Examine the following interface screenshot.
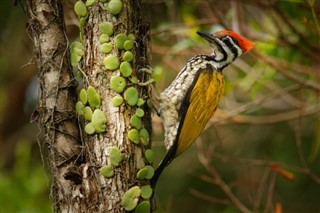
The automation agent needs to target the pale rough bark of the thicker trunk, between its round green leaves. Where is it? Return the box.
[82,0,151,212]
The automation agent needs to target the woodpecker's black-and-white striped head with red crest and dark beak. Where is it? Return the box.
[197,30,254,69]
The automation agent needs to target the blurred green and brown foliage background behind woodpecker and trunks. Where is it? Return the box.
[0,0,320,213]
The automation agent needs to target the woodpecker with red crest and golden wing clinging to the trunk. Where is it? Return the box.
[151,30,254,188]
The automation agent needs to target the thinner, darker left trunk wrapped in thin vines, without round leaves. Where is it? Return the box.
[25,0,81,212]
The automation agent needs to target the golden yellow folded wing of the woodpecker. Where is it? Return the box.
[175,69,224,157]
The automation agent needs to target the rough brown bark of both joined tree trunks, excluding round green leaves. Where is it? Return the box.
[26,0,151,212]
